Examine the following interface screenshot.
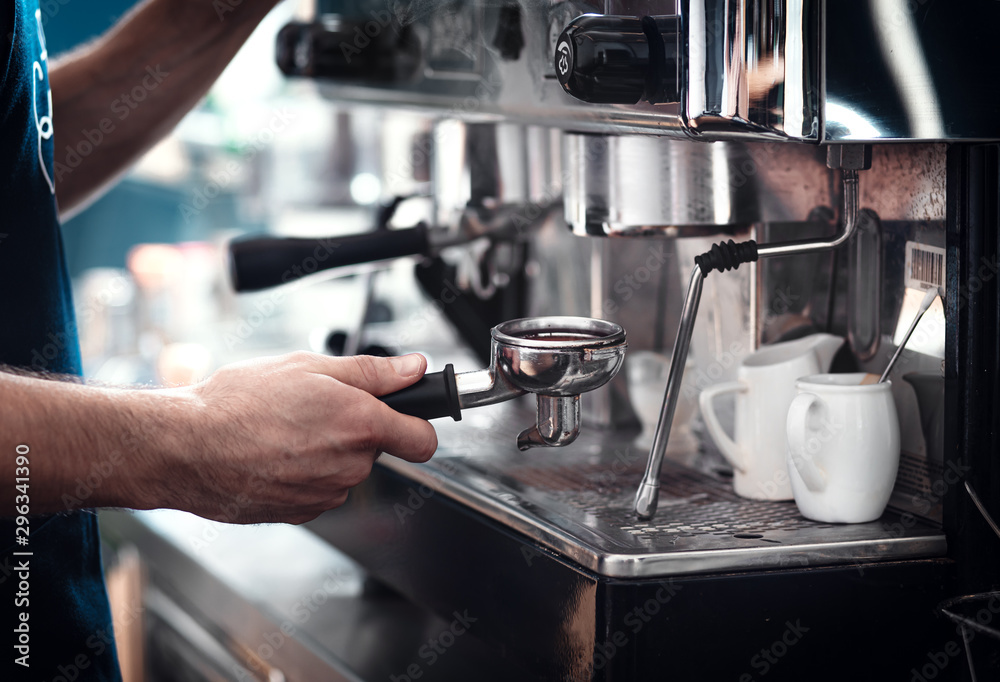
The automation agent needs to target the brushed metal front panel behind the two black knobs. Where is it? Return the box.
[304,0,687,137]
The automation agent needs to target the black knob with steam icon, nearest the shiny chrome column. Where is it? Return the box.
[555,14,680,104]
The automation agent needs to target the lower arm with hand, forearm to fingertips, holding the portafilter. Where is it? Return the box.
[0,353,437,523]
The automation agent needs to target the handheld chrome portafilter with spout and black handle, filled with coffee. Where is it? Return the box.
[380,317,627,450]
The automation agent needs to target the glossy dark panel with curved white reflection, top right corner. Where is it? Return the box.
[823,0,1000,142]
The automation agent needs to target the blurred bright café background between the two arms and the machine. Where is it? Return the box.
[53,0,453,384]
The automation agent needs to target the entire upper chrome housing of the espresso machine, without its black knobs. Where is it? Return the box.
[296,0,1000,142]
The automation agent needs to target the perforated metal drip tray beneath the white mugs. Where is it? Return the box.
[379,406,946,578]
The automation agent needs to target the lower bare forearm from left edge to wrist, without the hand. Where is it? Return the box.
[0,372,194,516]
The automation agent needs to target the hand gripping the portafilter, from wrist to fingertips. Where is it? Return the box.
[166,353,437,523]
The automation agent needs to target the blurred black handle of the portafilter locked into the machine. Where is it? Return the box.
[229,223,430,291]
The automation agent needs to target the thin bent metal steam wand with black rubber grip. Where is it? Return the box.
[634,167,871,519]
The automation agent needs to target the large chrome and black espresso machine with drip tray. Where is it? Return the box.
[225,0,1000,680]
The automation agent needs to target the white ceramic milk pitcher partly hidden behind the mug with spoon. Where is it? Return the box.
[699,334,844,500]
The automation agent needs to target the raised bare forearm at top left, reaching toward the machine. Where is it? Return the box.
[50,0,277,216]
